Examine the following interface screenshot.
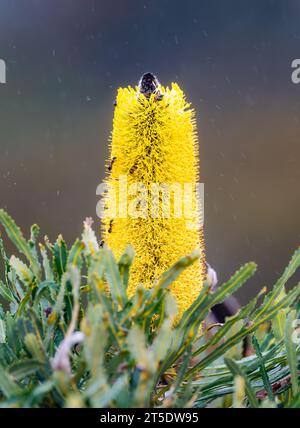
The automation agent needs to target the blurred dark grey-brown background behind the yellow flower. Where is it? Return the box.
[0,0,300,302]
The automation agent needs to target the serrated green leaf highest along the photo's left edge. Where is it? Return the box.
[0,209,40,278]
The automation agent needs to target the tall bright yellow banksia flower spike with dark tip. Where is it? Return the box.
[102,73,206,315]
